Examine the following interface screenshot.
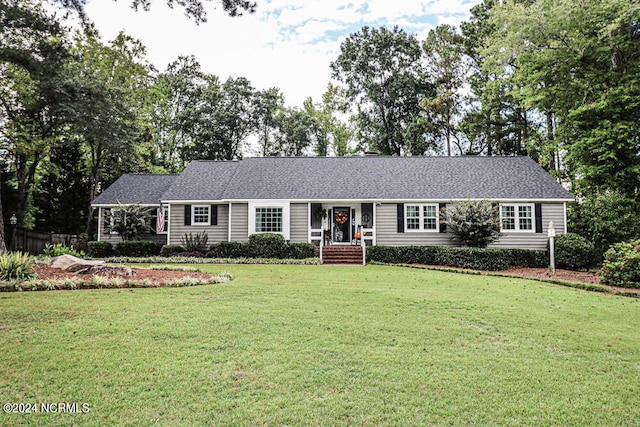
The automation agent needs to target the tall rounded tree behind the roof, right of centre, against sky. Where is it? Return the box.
[331,27,434,155]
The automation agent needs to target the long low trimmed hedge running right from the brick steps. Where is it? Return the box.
[367,246,549,271]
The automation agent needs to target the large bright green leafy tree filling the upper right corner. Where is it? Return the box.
[483,0,640,197]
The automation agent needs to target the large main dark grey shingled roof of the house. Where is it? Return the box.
[158,156,573,201]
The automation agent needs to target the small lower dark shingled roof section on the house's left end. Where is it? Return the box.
[91,174,178,205]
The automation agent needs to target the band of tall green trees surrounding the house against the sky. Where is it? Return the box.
[0,0,640,258]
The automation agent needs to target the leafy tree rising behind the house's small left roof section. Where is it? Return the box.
[67,33,150,232]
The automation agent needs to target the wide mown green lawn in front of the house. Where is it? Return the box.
[0,265,640,426]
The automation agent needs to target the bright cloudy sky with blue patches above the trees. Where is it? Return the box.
[87,0,481,106]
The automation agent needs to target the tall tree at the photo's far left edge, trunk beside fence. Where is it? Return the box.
[0,0,70,234]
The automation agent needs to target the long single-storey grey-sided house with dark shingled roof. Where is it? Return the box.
[92,156,573,249]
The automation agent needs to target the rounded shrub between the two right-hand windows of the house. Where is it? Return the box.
[443,200,500,248]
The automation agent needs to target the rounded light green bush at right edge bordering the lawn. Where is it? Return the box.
[600,240,640,288]
